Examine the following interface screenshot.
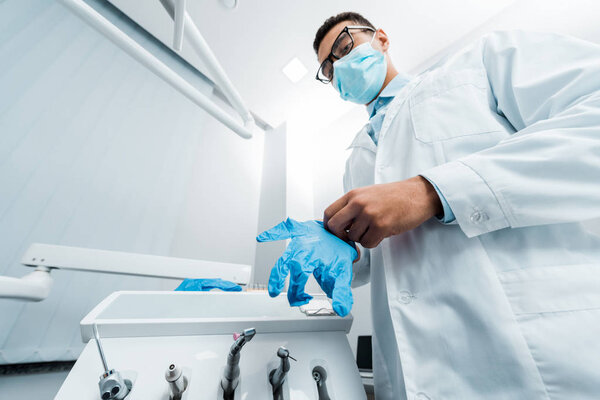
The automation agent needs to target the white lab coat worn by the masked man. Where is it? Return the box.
[344,32,600,400]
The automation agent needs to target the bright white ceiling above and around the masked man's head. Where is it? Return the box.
[109,0,514,126]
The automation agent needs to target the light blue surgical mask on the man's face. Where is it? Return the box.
[333,36,387,104]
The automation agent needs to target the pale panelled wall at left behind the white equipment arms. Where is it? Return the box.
[0,0,263,368]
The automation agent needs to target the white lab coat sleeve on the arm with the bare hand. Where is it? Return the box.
[423,32,600,237]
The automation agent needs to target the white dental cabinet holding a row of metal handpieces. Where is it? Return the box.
[55,291,366,400]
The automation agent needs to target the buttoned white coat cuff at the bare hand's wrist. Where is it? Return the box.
[420,161,510,237]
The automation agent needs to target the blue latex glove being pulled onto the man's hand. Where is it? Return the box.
[256,218,358,317]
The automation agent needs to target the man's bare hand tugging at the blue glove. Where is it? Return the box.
[323,176,443,248]
